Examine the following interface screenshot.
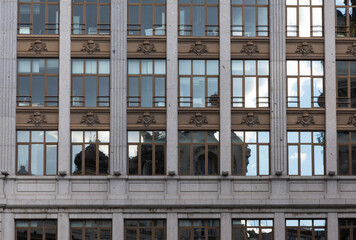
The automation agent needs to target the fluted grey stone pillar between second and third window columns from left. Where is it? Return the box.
[110,0,127,175]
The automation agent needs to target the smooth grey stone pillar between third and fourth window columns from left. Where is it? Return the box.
[166,0,178,174]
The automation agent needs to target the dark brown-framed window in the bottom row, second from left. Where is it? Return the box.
[70,220,112,240]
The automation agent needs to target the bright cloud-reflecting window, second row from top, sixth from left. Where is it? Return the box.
[287,60,325,108]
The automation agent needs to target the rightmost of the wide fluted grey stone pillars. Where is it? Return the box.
[269,0,287,174]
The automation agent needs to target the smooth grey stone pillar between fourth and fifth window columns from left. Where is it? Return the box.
[219,0,231,174]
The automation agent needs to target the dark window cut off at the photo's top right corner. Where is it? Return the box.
[335,0,356,37]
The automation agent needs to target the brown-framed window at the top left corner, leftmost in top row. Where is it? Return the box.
[18,0,59,34]
